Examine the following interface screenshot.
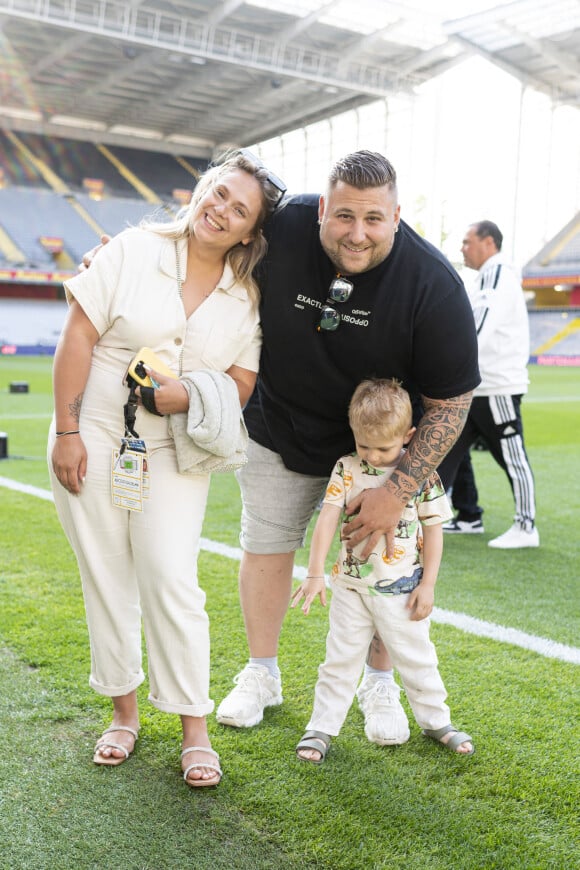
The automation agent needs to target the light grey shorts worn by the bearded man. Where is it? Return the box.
[236,441,328,555]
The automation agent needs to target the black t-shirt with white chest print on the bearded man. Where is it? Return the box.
[245,195,480,476]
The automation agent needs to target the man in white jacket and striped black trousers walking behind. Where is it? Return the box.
[439,221,540,550]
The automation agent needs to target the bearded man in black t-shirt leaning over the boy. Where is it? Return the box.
[217,151,479,743]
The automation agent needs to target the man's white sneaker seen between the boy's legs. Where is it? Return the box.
[356,674,409,746]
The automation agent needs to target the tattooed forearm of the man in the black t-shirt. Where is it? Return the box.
[391,392,472,497]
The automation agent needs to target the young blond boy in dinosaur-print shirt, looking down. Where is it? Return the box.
[292,379,474,764]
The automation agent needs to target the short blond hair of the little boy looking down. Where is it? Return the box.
[348,378,413,437]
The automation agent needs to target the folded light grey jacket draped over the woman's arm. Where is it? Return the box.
[169,369,248,474]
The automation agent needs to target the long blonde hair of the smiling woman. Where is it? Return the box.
[139,151,281,305]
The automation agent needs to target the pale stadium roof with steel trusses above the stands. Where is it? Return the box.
[0,0,580,157]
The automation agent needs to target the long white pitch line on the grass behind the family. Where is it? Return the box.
[0,477,580,665]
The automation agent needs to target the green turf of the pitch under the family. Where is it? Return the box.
[0,358,580,870]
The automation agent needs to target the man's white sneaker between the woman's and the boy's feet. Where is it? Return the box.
[216,665,282,728]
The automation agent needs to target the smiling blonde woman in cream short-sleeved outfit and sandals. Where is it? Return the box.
[49,151,284,787]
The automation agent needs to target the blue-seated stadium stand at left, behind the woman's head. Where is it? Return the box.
[0,130,205,286]
